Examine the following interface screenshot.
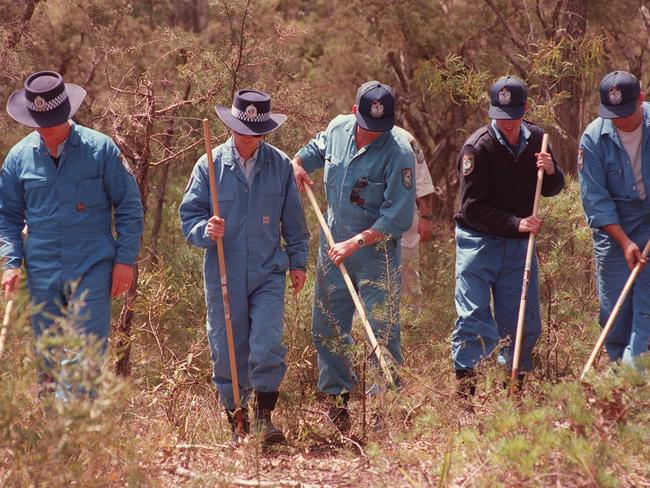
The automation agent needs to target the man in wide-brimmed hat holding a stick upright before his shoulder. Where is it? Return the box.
[180,90,309,443]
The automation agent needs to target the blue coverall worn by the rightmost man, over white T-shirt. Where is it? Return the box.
[578,103,650,364]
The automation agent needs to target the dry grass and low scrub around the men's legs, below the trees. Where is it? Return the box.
[0,181,650,487]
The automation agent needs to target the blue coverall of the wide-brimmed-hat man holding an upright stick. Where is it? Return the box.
[179,140,308,410]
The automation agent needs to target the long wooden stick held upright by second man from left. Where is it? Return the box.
[203,119,244,433]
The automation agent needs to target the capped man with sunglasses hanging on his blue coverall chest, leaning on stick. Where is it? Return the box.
[292,81,415,430]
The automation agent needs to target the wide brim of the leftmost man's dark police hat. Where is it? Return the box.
[7,83,86,128]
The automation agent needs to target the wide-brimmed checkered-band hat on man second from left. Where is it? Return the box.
[215,89,287,136]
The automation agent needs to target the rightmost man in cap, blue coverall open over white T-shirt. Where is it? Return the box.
[578,71,650,364]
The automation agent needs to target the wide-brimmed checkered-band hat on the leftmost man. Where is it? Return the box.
[7,71,86,128]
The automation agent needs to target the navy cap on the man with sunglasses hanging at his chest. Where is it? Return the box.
[356,80,395,132]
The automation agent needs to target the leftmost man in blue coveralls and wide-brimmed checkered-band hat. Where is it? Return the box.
[0,71,143,392]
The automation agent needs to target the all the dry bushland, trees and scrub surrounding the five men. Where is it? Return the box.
[0,0,650,486]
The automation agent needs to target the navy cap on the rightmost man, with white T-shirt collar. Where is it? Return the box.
[598,71,641,119]
